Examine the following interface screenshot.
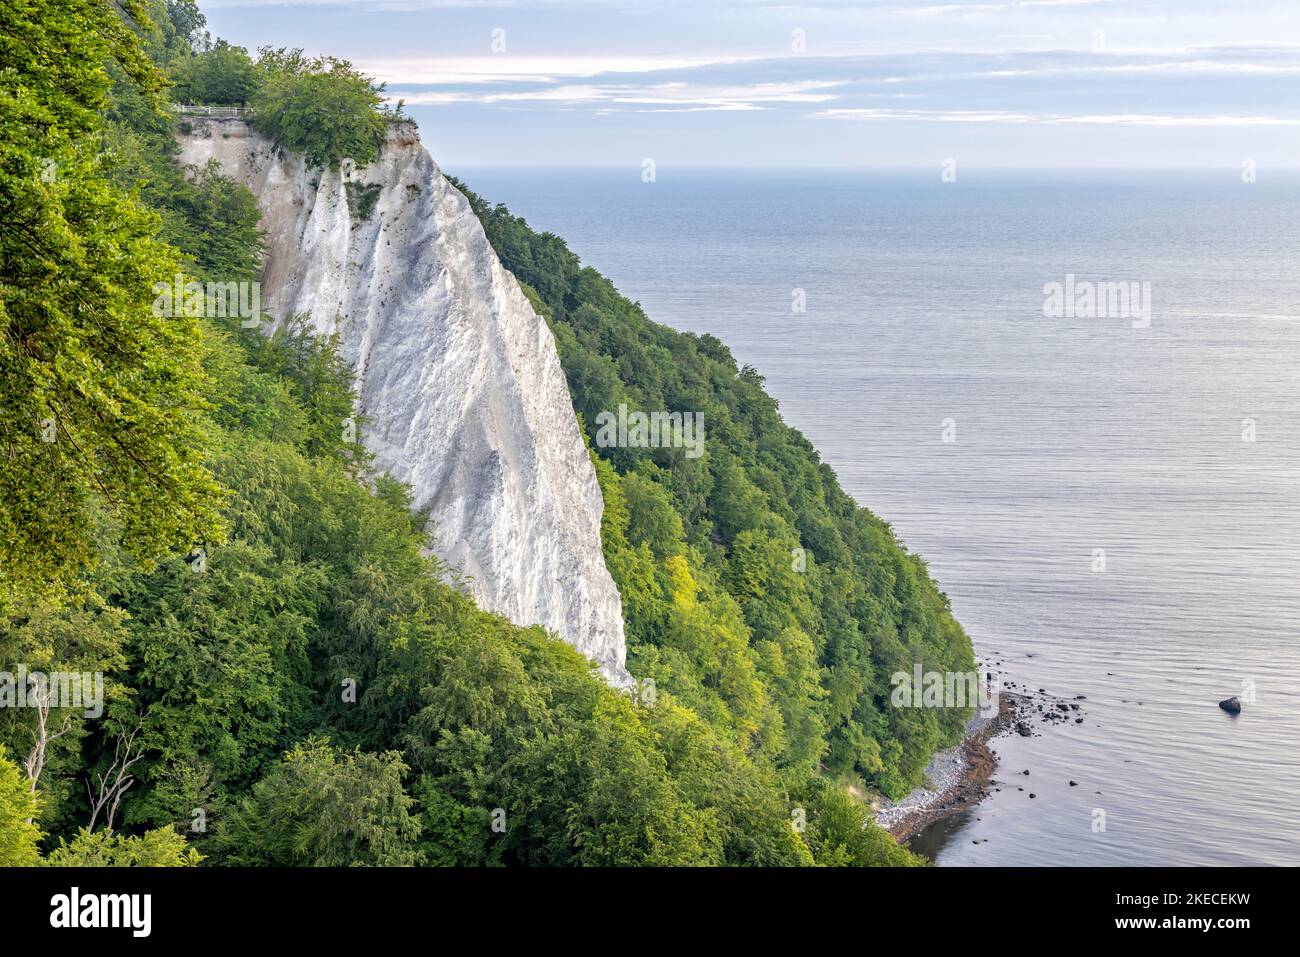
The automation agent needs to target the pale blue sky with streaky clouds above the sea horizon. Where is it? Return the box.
[200,0,1300,167]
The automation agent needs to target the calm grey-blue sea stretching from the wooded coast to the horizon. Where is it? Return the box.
[452,166,1300,865]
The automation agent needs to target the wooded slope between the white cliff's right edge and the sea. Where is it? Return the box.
[462,185,975,797]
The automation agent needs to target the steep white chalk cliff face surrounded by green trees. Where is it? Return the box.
[179,118,631,685]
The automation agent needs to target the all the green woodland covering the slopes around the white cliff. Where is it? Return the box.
[0,0,972,866]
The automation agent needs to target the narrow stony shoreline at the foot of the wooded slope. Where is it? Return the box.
[876,692,1024,844]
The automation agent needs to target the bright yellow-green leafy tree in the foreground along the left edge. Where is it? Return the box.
[0,0,221,603]
